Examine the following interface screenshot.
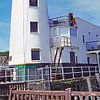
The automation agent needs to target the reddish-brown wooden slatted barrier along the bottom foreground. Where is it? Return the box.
[9,89,100,100]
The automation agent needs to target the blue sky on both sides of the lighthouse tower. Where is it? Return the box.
[0,0,100,51]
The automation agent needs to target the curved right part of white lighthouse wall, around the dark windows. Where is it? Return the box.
[25,0,50,63]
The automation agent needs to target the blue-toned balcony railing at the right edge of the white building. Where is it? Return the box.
[86,40,100,51]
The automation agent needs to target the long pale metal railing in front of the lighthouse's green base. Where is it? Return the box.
[0,65,99,82]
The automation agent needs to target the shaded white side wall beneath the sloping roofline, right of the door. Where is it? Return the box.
[77,18,100,63]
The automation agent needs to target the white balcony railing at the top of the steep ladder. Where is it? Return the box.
[50,36,71,47]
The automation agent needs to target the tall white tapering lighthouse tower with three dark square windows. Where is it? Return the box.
[9,0,50,80]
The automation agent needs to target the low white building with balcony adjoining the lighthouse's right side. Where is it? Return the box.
[50,16,100,64]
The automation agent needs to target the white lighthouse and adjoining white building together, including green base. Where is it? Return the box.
[9,0,100,81]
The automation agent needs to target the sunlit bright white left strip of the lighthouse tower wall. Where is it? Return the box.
[9,0,24,65]
